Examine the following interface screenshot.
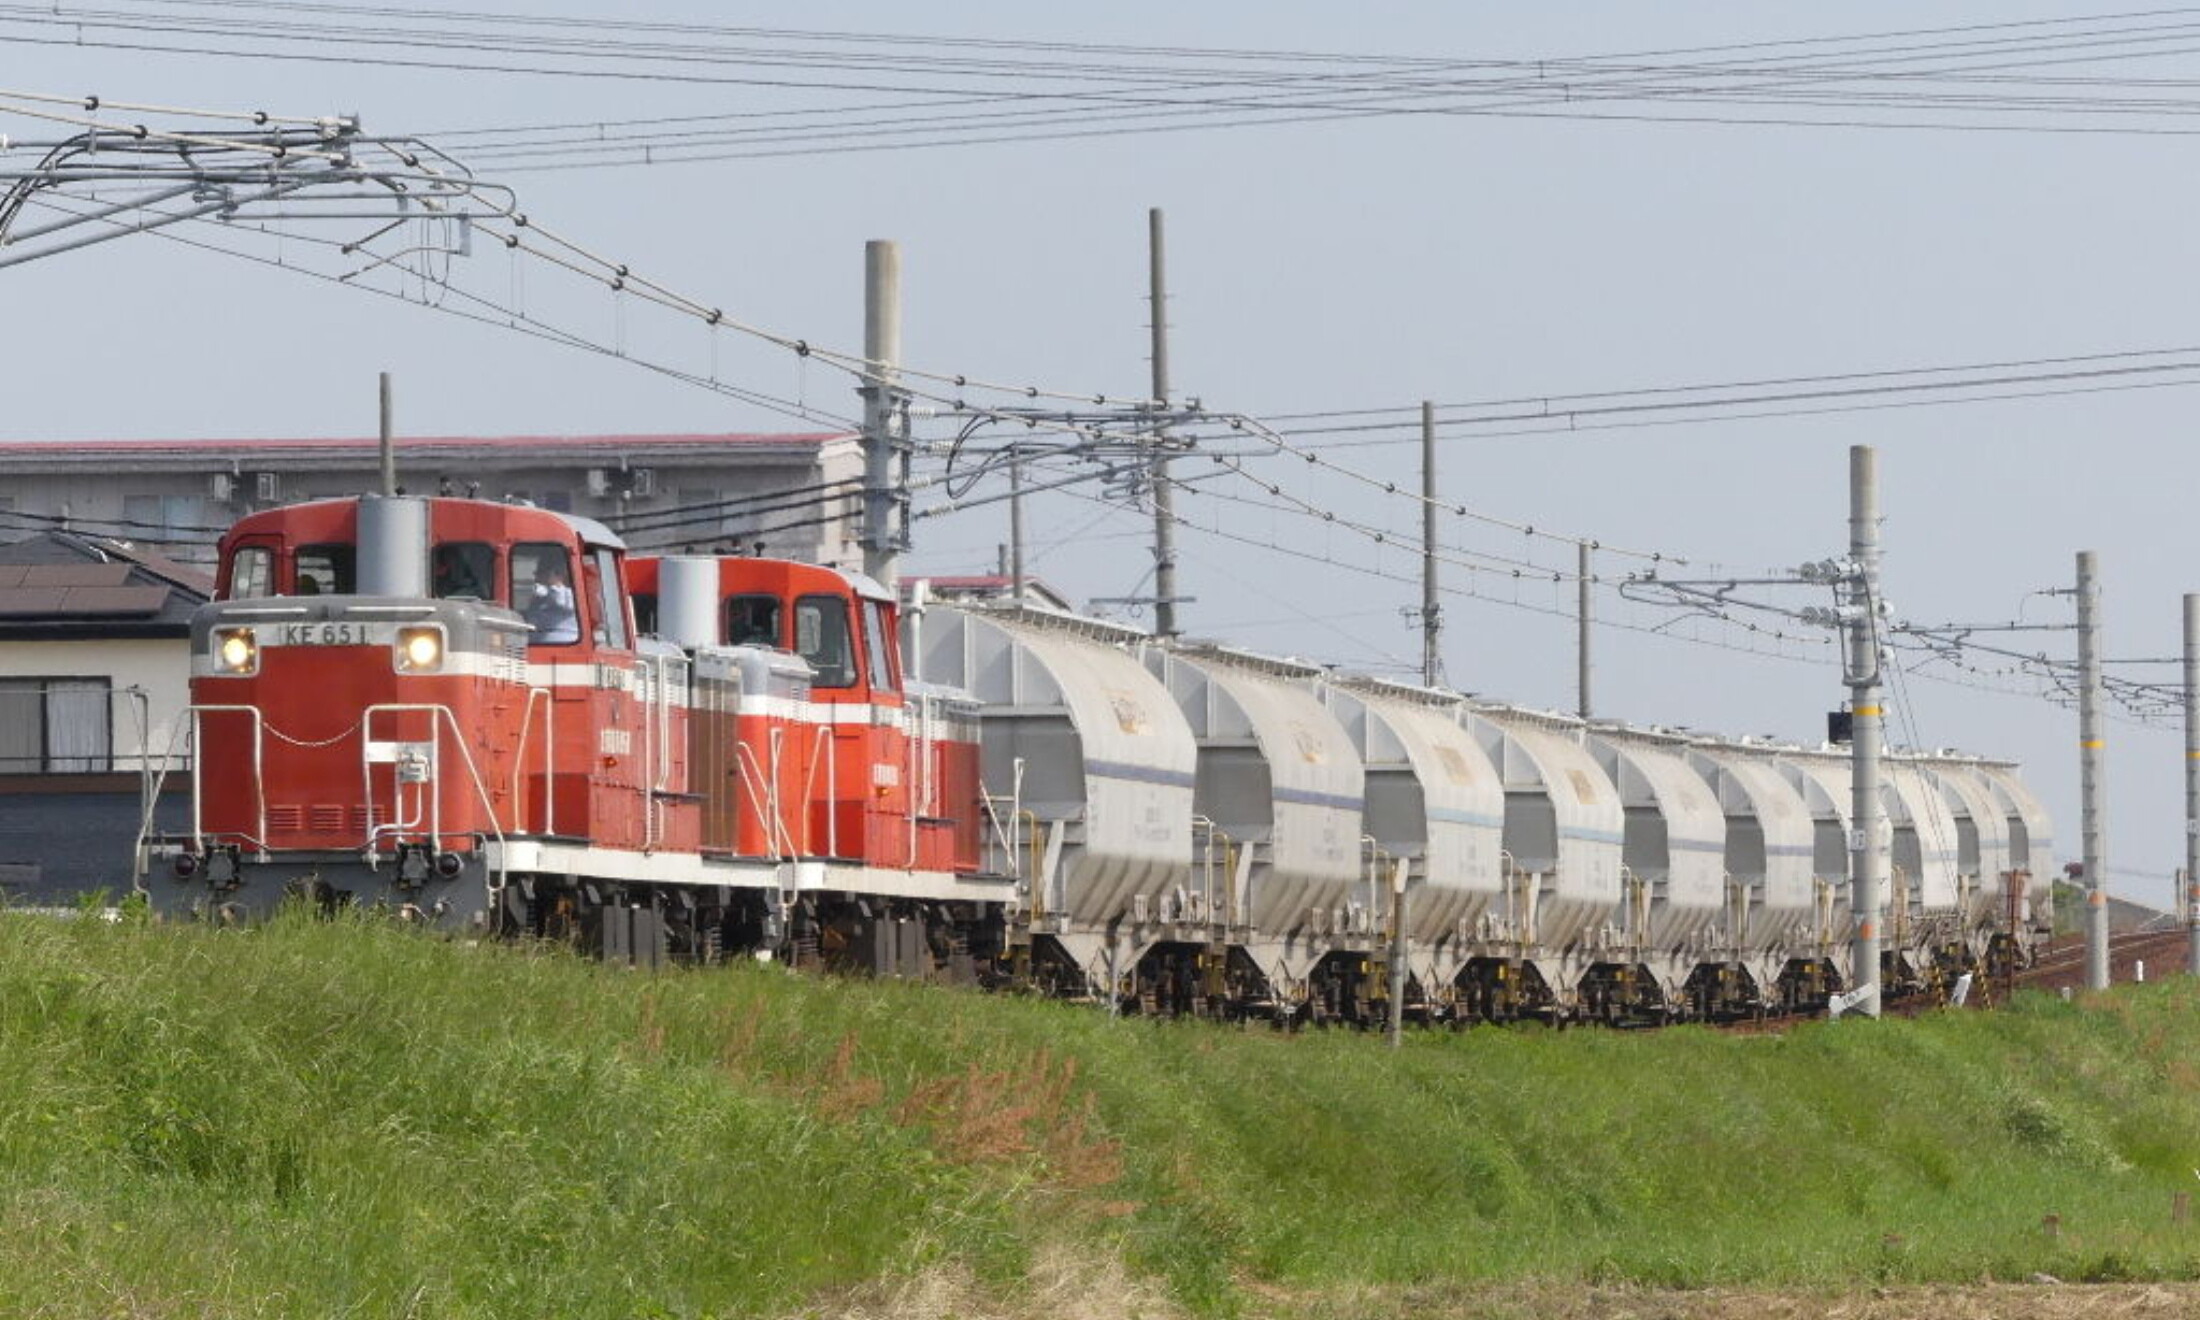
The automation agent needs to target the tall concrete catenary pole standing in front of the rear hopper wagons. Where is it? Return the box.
[1848,444,1888,1016]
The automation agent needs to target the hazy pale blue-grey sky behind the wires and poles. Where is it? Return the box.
[0,0,2200,904]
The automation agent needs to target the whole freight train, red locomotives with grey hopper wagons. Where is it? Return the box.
[139,495,2050,1023]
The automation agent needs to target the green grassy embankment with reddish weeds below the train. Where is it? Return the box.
[0,913,2200,1318]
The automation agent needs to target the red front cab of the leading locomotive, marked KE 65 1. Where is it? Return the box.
[152,497,693,924]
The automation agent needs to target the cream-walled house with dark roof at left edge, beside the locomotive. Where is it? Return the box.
[0,530,213,902]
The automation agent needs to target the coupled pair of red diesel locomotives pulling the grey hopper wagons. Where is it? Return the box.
[145,497,1012,975]
